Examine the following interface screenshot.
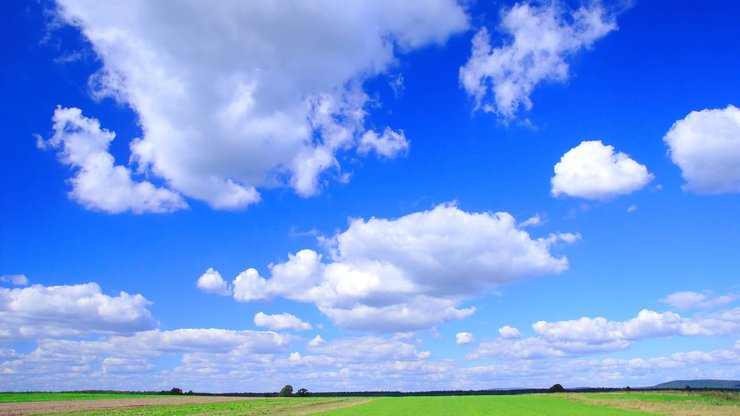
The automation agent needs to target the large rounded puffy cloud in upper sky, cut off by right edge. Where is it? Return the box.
[663,105,740,194]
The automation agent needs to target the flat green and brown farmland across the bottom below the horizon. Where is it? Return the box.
[0,392,740,416]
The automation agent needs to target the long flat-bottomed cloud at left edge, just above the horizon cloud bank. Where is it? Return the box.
[0,283,157,343]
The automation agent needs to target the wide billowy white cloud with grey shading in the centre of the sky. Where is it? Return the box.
[205,205,575,332]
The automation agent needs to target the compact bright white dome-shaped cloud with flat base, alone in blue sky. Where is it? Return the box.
[550,140,653,199]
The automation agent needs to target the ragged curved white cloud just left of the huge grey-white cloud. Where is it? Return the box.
[38,107,187,214]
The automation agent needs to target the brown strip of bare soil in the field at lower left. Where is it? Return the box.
[0,396,259,416]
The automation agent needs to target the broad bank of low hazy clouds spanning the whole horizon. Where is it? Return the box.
[0,283,740,391]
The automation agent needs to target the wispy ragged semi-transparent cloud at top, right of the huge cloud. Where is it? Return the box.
[460,1,617,119]
